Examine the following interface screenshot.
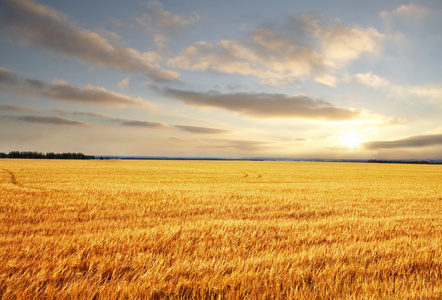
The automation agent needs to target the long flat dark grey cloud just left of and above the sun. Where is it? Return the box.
[161,88,360,121]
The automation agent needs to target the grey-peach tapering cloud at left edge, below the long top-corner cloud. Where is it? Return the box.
[0,68,153,108]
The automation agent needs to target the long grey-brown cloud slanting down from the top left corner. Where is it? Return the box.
[0,0,179,80]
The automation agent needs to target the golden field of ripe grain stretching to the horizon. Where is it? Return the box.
[0,159,442,299]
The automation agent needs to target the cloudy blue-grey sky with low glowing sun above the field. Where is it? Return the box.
[0,0,442,159]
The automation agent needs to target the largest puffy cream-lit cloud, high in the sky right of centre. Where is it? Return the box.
[168,14,384,86]
